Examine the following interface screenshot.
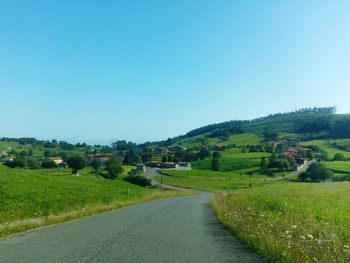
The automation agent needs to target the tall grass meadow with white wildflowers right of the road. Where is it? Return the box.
[211,182,350,262]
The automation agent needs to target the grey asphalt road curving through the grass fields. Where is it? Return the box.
[0,193,261,263]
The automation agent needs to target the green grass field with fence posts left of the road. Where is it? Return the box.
[0,165,189,236]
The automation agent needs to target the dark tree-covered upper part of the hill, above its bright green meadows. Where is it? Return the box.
[152,107,350,144]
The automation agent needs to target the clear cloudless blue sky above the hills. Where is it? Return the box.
[0,0,350,144]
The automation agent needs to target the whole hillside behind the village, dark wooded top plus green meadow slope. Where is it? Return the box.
[149,107,350,147]
